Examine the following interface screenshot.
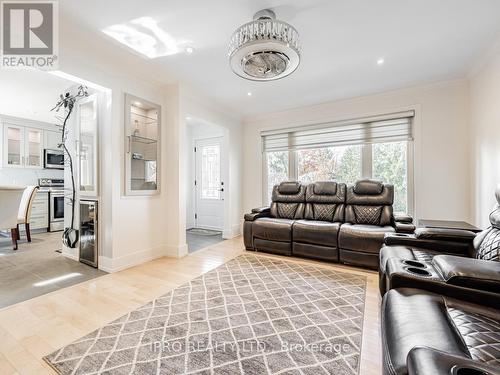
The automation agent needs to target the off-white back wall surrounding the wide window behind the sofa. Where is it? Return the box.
[243,80,471,220]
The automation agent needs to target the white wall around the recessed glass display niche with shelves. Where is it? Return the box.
[60,19,184,271]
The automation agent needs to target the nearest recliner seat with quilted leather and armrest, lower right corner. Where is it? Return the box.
[381,288,500,375]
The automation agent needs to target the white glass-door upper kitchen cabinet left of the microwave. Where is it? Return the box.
[2,123,43,168]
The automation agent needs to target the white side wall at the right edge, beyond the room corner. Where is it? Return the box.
[470,43,500,228]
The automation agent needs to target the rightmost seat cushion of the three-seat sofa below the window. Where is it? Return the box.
[338,223,395,254]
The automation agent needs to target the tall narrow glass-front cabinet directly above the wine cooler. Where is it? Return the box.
[78,95,98,196]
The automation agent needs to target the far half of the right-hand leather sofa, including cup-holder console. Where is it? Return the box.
[379,187,500,298]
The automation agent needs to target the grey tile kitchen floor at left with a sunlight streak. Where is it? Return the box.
[0,232,106,308]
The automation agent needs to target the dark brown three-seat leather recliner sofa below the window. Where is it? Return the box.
[243,180,415,269]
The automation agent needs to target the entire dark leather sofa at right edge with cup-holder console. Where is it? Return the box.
[379,186,500,375]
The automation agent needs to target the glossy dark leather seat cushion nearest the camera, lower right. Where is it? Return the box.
[381,288,476,374]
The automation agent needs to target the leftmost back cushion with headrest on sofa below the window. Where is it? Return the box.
[271,181,306,219]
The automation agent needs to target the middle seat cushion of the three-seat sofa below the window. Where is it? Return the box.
[293,220,341,247]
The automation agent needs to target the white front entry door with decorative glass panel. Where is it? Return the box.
[195,138,224,230]
